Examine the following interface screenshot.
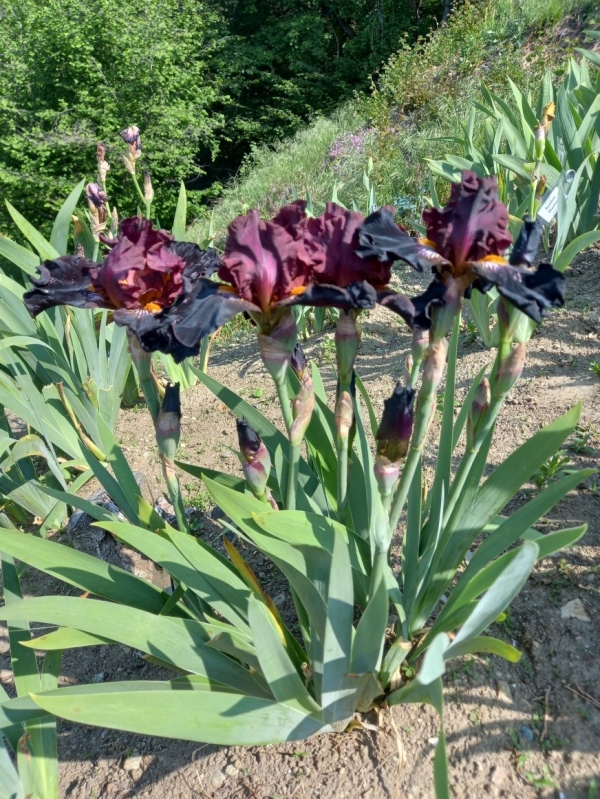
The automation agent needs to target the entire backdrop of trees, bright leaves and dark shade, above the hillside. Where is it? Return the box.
[0,0,444,232]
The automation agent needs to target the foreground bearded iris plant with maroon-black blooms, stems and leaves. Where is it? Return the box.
[7,169,591,799]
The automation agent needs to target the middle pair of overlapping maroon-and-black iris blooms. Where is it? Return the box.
[136,200,426,358]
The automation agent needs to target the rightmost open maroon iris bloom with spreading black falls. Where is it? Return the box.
[358,170,565,327]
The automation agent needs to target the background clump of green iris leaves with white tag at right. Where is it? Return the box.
[429,56,600,347]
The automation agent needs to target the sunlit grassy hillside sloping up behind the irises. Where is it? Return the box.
[190,0,600,242]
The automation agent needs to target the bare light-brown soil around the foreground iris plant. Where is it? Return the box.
[0,250,600,799]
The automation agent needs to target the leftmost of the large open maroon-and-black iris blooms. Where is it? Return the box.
[23,217,218,357]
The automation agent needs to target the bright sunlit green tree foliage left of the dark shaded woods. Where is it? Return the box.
[0,0,221,231]
